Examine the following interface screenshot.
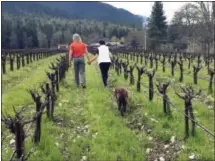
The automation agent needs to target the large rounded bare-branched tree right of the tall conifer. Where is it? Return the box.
[168,2,213,53]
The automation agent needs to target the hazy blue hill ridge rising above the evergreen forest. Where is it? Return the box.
[2,2,143,28]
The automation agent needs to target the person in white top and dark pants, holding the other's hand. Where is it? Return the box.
[88,40,112,87]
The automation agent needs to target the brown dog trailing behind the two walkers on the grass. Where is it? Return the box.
[114,88,128,116]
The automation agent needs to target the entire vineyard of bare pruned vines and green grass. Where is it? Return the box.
[2,49,215,161]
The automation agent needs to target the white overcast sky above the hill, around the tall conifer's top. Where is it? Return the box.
[103,2,188,22]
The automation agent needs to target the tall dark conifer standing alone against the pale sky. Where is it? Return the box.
[148,2,167,50]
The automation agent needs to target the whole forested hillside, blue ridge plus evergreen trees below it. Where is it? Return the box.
[2,2,144,49]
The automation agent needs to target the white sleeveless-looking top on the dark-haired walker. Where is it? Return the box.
[98,45,112,64]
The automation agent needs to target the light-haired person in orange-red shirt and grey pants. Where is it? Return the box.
[69,34,89,88]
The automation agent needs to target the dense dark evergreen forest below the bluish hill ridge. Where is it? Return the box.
[2,13,133,49]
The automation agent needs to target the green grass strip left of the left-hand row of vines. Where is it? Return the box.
[2,55,63,113]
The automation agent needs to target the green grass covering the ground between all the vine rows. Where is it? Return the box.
[2,55,214,161]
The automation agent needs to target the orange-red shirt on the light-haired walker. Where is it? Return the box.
[70,42,87,58]
